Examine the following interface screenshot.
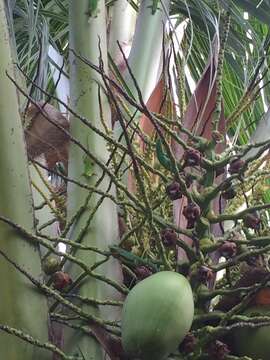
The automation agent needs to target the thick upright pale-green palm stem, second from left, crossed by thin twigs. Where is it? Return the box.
[65,0,120,360]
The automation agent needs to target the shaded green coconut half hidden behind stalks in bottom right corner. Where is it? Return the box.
[233,305,270,360]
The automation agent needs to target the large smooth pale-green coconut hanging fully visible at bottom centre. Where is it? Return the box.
[122,271,194,360]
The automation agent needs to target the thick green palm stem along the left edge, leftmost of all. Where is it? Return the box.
[0,0,51,360]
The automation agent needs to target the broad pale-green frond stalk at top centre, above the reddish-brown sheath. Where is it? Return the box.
[114,0,169,183]
